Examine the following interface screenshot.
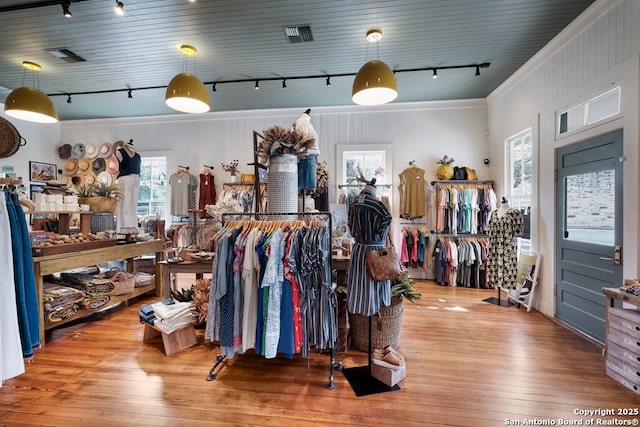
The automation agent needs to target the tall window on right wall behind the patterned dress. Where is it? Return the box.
[505,128,533,252]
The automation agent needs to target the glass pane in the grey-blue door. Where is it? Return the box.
[565,169,615,246]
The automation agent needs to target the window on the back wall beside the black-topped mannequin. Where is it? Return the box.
[137,157,167,219]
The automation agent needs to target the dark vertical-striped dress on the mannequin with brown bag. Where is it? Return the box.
[347,185,392,316]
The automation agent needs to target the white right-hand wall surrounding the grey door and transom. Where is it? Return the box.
[487,0,640,315]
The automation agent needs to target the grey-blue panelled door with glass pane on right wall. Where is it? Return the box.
[556,129,623,342]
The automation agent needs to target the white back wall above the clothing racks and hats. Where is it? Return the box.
[60,100,488,242]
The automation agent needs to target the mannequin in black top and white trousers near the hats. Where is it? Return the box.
[113,139,142,229]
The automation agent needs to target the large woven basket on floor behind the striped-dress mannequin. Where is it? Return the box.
[349,296,403,353]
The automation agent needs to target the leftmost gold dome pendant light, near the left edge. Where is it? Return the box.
[4,61,58,123]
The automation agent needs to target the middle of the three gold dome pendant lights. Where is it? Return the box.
[165,44,211,113]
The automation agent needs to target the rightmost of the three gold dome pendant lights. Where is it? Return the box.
[351,29,398,105]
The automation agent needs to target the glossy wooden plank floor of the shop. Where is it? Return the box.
[0,281,640,427]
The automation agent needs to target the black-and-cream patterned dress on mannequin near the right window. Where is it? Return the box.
[487,209,524,289]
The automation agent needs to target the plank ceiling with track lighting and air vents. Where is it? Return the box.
[0,0,593,120]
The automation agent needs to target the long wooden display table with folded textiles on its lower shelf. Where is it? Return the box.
[33,240,166,346]
